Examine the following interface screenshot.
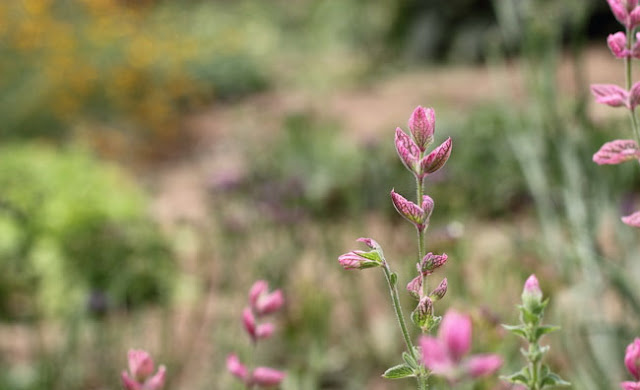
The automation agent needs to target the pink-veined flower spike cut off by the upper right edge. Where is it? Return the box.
[591,0,640,227]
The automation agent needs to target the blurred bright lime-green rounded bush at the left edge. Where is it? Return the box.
[0,145,174,319]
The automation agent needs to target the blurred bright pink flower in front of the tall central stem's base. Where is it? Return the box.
[420,310,502,382]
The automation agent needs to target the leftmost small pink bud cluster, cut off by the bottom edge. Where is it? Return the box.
[122,349,166,390]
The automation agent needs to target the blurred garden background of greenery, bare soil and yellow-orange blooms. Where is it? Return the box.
[0,0,640,390]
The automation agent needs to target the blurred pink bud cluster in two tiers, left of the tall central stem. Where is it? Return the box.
[227,280,285,388]
